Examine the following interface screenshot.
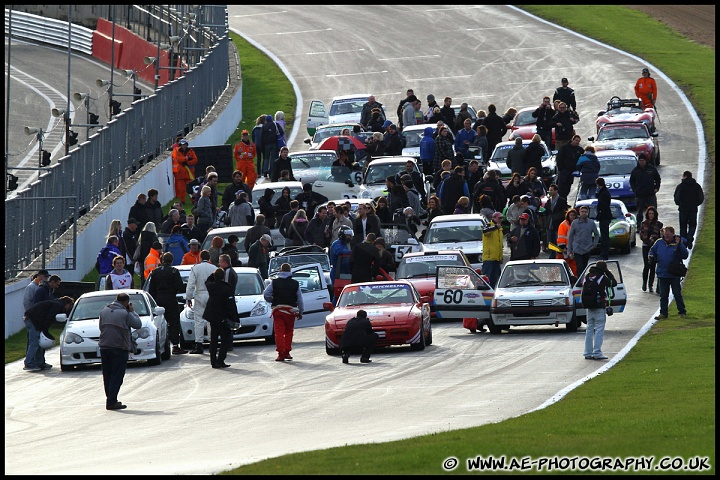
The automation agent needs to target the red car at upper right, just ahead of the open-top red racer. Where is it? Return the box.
[588,122,660,165]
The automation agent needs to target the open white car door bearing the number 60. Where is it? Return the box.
[435,266,494,319]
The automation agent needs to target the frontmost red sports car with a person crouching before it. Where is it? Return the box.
[323,280,432,355]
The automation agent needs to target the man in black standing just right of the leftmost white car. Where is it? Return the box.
[148,252,187,355]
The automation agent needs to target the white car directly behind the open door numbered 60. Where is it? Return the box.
[422,213,487,268]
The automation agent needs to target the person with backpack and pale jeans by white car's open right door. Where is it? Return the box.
[581,261,617,360]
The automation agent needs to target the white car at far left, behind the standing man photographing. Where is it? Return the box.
[56,289,171,372]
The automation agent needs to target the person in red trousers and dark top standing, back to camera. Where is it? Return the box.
[263,263,304,362]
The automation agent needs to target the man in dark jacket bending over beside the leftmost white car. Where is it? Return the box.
[23,297,75,372]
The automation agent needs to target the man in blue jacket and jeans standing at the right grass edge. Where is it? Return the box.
[648,225,688,320]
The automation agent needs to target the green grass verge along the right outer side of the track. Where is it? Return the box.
[224,6,715,475]
